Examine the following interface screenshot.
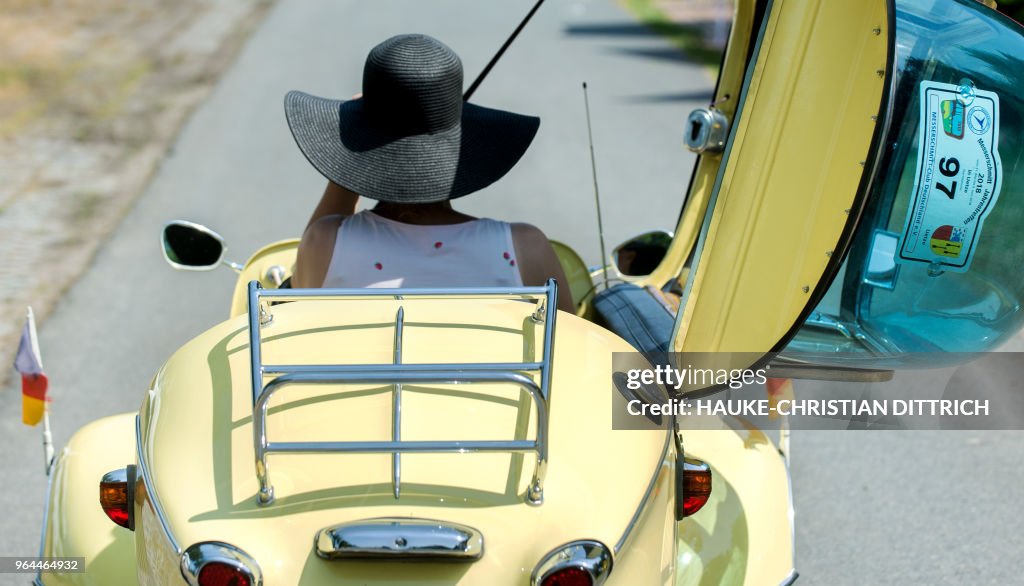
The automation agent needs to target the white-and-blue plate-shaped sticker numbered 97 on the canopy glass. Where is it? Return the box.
[896,81,1002,273]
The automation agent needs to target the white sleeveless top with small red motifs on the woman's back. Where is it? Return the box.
[324,210,522,288]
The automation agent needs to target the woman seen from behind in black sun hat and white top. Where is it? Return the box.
[285,35,572,311]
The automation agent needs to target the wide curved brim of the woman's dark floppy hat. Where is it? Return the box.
[285,91,541,204]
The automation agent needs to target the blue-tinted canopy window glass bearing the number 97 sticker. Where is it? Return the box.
[786,0,1024,360]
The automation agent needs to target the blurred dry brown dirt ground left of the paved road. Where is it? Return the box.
[0,0,272,386]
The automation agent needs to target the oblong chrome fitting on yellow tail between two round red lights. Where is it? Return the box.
[314,517,483,561]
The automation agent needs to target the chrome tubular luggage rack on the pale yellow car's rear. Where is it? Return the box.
[243,279,558,505]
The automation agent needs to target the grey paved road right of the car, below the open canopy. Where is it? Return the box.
[793,356,1024,584]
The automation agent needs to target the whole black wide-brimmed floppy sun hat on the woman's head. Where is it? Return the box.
[285,35,541,204]
